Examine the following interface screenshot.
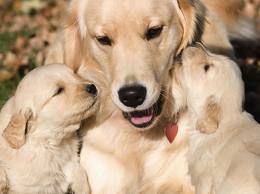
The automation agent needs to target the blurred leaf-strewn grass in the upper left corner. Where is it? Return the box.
[0,0,68,108]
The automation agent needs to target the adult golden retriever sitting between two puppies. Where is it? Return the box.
[46,0,258,194]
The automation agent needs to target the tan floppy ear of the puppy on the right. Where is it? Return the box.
[196,97,221,134]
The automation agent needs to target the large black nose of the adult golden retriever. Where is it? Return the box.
[118,85,146,108]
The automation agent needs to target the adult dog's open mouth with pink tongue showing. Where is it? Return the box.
[123,95,163,128]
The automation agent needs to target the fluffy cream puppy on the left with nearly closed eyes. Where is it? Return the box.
[0,64,98,194]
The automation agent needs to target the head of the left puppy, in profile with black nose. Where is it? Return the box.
[2,64,98,148]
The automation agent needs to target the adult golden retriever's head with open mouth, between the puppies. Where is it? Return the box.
[65,0,205,130]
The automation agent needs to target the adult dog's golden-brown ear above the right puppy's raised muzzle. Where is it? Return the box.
[173,0,206,54]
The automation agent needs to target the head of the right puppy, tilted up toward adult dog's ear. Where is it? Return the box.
[176,45,244,133]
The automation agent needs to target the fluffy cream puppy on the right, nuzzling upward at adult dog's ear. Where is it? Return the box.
[173,47,260,194]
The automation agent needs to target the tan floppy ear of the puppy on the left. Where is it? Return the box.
[3,110,32,149]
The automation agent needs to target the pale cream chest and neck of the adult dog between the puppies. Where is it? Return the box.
[79,67,194,194]
